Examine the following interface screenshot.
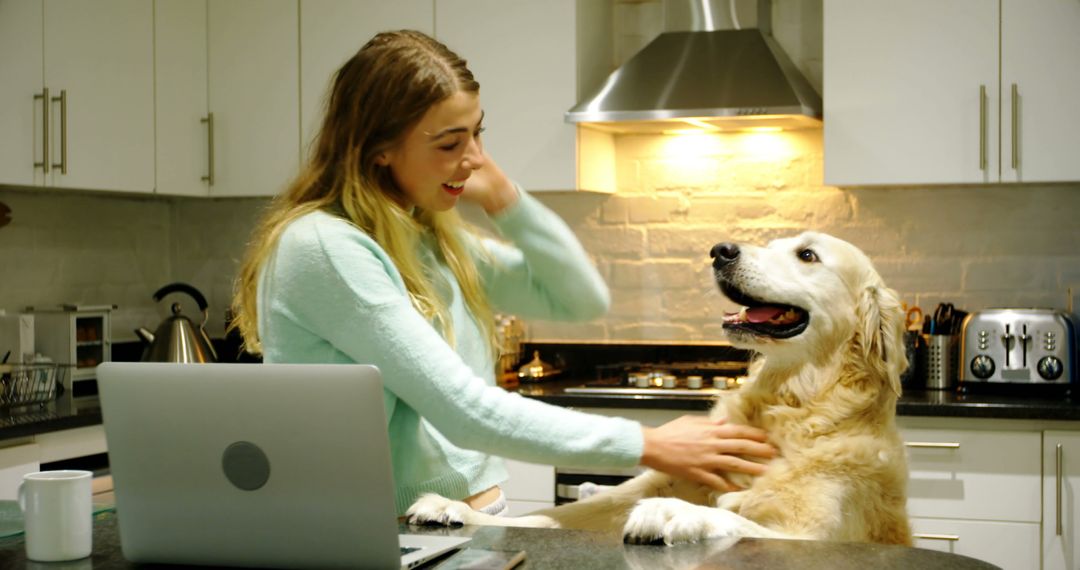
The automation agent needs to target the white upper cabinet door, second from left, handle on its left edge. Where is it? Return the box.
[42,0,154,192]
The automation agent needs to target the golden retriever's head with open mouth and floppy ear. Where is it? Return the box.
[711,232,907,391]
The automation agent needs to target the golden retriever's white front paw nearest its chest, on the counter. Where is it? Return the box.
[622,499,740,545]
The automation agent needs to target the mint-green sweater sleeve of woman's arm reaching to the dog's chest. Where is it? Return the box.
[265,215,644,466]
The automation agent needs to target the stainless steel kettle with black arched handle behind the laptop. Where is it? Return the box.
[135,283,217,363]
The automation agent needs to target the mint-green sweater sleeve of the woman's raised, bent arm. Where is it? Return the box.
[477,189,611,321]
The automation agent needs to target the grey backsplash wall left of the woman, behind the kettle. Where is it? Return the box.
[0,189,259,340]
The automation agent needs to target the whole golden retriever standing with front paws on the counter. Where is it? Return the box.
[408,232,912,545]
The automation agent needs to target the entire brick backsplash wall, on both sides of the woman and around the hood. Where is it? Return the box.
[0,0,1080,341]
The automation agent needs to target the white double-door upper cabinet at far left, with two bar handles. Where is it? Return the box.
[0,0,154,192]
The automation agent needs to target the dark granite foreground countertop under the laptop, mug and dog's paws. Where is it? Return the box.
[0,512,995,570]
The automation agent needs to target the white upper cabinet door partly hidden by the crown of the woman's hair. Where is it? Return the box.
[300,0,434,152]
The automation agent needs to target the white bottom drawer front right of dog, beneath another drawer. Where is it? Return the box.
[912,518,1040,570]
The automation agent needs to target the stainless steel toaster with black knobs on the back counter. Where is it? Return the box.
[960,309,1077,384]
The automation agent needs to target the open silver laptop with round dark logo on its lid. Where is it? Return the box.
[97,363,470,568]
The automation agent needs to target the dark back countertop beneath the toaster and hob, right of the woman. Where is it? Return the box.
[514,377,1080,421]
